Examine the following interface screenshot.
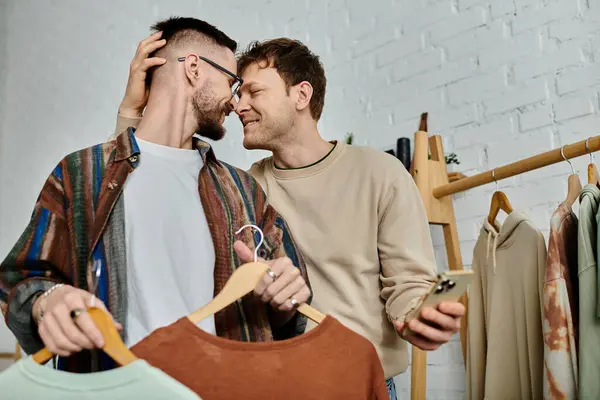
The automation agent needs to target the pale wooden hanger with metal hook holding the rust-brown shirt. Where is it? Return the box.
[188,225,325,324]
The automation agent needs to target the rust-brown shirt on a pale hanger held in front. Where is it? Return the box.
[131,316,389,400]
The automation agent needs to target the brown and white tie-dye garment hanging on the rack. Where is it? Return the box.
[542,203,578,400]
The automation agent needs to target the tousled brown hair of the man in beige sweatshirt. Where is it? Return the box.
[238,38,327,121]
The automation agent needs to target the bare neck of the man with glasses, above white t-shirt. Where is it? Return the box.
[135,91,194,149]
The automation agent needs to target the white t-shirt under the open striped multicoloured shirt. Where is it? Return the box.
[124,138,215,346]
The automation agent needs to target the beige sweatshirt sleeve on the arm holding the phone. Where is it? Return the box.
[377,162,436,321]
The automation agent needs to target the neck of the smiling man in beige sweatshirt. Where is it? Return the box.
[273,127,334,169]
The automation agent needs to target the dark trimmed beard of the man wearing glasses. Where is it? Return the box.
[192,82,230,140]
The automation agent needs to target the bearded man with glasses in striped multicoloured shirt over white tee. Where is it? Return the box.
[0,18,311,372]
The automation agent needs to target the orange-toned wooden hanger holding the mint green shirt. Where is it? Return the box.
[32,307,138,365]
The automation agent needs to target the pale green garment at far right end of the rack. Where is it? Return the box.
[577,185,600,399]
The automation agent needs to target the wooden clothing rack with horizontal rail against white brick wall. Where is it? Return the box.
[411,113,600,400]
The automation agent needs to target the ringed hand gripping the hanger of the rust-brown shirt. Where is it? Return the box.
[233,240,310,316]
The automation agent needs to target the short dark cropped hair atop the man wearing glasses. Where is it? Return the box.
[151,17,237,53]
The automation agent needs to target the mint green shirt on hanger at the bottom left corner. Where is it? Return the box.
[0,357,200,400]
